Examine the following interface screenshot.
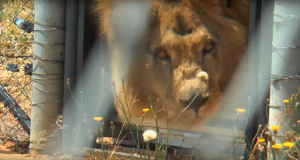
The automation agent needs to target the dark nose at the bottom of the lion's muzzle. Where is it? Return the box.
[179,94,208,117]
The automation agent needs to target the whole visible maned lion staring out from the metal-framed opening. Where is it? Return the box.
[94,0,249,128]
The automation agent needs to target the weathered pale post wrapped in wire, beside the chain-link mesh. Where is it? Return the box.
[30,0,66,154]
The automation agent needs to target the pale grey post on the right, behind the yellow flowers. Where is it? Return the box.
[268,0,300,159]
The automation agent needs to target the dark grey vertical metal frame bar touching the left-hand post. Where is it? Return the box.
[62,0,79,153]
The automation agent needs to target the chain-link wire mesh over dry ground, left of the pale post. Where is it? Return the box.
[0,0,35,144]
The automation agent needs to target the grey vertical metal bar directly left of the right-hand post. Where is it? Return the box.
[255,0,274,160]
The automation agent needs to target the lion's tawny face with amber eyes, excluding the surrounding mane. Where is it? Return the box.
[145,5,221,119]
